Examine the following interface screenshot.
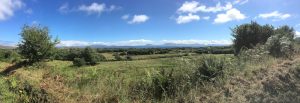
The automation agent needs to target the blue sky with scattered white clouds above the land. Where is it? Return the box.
[0,0,300,46]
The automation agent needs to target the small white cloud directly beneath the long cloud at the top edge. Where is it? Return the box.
[176,13,200,24]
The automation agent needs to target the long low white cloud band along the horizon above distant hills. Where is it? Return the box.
[58,39,232,47]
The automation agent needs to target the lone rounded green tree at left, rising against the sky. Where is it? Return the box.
[18,25,59,63]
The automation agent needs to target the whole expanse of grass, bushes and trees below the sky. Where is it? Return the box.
[0,22,300,103]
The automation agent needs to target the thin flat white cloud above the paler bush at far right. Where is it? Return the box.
[258,11,291,21]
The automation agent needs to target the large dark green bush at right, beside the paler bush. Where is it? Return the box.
[232,22,274,55]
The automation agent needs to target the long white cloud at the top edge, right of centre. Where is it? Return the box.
[177,1,232,13]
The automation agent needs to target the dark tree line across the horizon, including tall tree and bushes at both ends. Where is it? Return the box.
[0,22,300,66]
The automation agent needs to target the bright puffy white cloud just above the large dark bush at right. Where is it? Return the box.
[214,8,246,23]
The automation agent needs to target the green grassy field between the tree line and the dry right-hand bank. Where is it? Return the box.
[0,54,298,103]
